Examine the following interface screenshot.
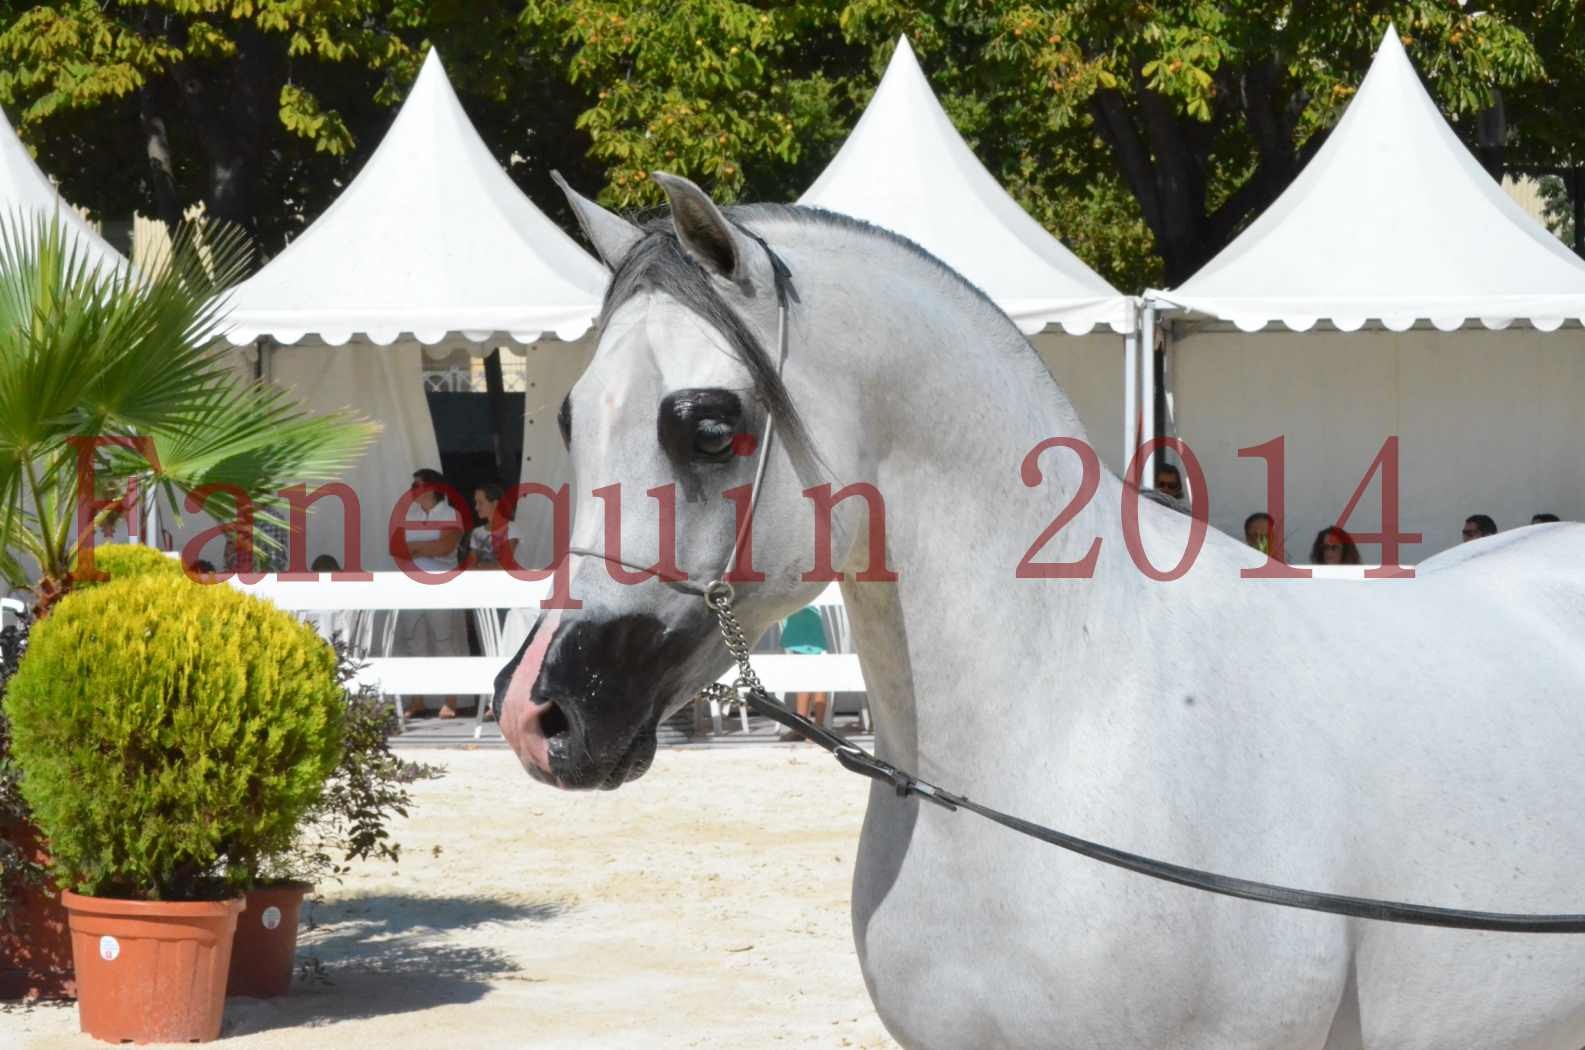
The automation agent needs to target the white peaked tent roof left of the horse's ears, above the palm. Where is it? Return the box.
[228,49,605,346]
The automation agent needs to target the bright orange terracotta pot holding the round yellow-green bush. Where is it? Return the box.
[60,891,246,1042]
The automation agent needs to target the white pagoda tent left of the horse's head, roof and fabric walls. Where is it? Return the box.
[228,51,607,569]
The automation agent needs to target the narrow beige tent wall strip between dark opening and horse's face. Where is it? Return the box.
[515,335,596,568]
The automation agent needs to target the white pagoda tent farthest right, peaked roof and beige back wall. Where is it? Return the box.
[1144,30,1585,563]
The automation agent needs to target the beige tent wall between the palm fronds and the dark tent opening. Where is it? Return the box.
[268,343,440,573]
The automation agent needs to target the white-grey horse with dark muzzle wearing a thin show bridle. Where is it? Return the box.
[499,174,1585,1050]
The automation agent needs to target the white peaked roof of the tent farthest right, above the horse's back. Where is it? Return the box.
[1149,29,1585,331]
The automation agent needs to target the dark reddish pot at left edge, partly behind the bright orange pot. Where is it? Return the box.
[0,823,78,999]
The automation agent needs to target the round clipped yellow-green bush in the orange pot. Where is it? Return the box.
[5,576,346,899]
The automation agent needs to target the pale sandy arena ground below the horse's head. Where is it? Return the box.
[9,745,896,1050]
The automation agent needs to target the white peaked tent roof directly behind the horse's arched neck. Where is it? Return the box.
[799,36,1133,333]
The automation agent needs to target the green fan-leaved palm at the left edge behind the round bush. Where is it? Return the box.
[0,216,374,612]
